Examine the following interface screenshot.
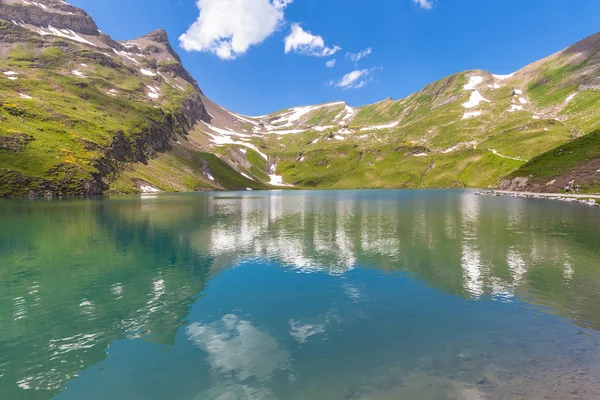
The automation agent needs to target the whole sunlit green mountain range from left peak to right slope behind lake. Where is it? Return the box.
[0,0,600,196]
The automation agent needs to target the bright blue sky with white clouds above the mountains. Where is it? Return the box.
[69,0,600,115]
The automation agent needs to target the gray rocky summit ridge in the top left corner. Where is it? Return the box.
[0,0,99,35]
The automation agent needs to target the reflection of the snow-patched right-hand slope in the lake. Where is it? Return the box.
[198,192,600,328]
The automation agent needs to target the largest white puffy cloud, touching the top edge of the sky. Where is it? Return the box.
[179,0,293,60]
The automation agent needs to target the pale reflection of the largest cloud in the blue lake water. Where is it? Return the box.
[186,314,290,400]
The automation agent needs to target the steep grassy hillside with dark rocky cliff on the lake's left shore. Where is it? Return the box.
[0,16,264,196]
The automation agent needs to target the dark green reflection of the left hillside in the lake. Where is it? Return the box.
[0,203,211,399]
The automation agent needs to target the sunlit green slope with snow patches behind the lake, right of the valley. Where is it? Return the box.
[191,34,600,188]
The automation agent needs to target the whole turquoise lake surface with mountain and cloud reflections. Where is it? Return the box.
[0,190,600,400]
